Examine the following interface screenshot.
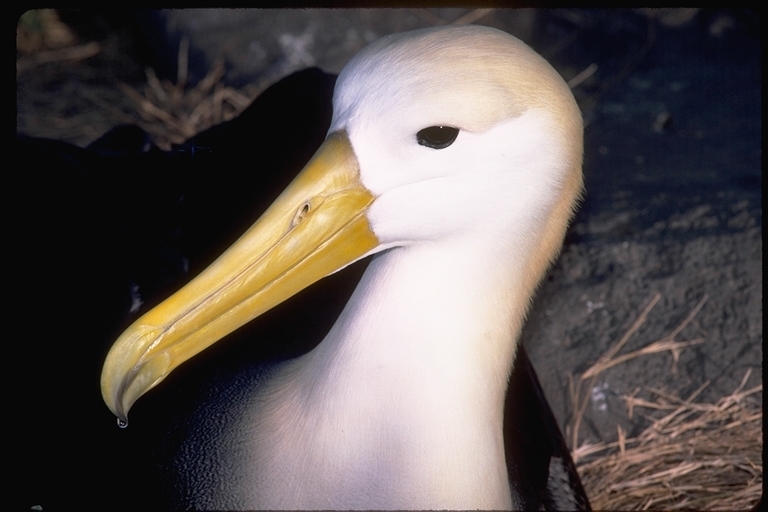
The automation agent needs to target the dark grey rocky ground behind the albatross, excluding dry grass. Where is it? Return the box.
[17,9,763,504]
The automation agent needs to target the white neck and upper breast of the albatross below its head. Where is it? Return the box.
[243,238,527,509]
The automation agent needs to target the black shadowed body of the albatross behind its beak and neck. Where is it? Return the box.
[16,69,588,510]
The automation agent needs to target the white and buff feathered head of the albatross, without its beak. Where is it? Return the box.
[329,26,583,292]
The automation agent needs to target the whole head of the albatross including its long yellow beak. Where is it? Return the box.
[101,26,582,421]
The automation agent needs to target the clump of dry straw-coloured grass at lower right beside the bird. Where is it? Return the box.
[572,295,763,510]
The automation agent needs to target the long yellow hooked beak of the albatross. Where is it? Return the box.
[101,132,379,423]
